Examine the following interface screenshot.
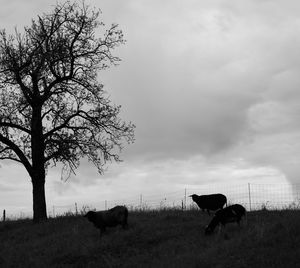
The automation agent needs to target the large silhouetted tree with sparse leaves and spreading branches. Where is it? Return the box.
[0,2,134,222]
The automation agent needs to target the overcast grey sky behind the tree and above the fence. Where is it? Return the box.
[0,0,300,214]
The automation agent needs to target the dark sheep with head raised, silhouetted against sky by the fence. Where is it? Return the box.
[190,194,227,215]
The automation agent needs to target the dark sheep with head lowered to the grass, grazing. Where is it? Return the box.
[205,204,246,234]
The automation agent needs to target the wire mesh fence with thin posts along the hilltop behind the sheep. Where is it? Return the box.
[48,183,300,217]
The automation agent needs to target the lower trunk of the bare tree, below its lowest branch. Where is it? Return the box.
[32,178,47,222]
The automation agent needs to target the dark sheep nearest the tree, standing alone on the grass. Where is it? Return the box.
[84,206,128,236]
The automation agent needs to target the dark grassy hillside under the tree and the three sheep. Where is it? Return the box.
[0,210,300,268]
